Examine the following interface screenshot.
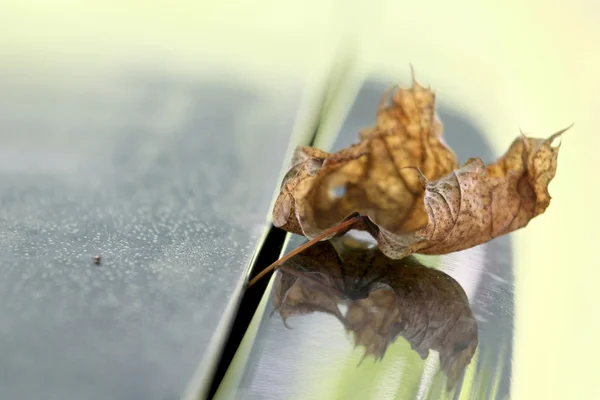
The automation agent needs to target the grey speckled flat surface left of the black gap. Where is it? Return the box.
[0,74,300,399]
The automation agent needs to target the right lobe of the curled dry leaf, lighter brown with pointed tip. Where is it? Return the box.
[376,130,565,258]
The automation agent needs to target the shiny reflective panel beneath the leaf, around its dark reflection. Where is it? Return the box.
[218,82,514,399]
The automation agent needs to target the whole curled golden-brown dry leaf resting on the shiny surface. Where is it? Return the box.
[273,72,568,258]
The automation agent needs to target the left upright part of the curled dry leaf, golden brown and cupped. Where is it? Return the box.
[273,81,457,237]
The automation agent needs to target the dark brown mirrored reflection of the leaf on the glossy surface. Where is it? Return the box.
[274,237,478,389]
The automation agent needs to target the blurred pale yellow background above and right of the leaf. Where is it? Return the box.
[0,0,600,400]
